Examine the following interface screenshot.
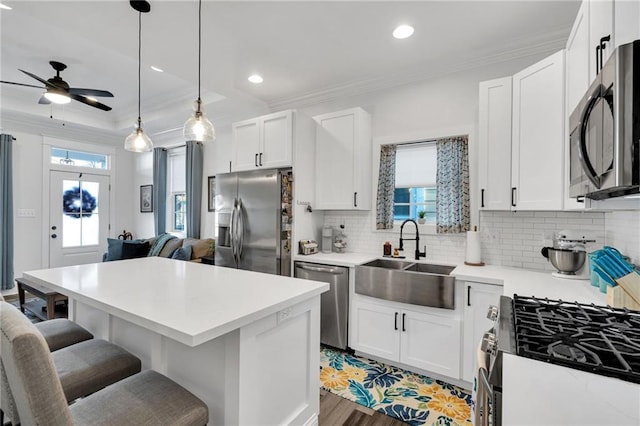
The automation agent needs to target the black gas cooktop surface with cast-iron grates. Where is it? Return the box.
[513,295,640,383]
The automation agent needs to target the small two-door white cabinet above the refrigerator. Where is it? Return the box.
[232,110,293,172]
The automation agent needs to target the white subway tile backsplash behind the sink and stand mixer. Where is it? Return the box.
[324,211,640,271]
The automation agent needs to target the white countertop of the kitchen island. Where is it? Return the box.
[24,257,329,346]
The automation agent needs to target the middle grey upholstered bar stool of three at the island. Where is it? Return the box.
[0,302,142,423]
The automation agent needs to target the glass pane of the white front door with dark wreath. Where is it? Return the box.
[62,179,100,248]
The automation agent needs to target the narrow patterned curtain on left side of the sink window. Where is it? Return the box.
[376,145,396,229]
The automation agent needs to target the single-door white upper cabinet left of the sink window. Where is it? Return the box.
[313,108,372,210]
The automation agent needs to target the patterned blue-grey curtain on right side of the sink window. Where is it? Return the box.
[436,136,471,234]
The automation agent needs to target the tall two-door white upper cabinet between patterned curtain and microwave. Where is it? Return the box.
[479,51,565,210]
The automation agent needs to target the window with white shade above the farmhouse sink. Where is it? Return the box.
[393,142,438,224]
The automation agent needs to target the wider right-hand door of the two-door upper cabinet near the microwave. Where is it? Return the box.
[510,50,565,210]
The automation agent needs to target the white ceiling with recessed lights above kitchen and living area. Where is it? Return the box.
[0,0,580,140]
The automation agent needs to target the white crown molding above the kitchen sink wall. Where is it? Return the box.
[267,27,568,111]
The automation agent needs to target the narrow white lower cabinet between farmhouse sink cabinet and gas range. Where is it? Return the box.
[462,281,502,383]
